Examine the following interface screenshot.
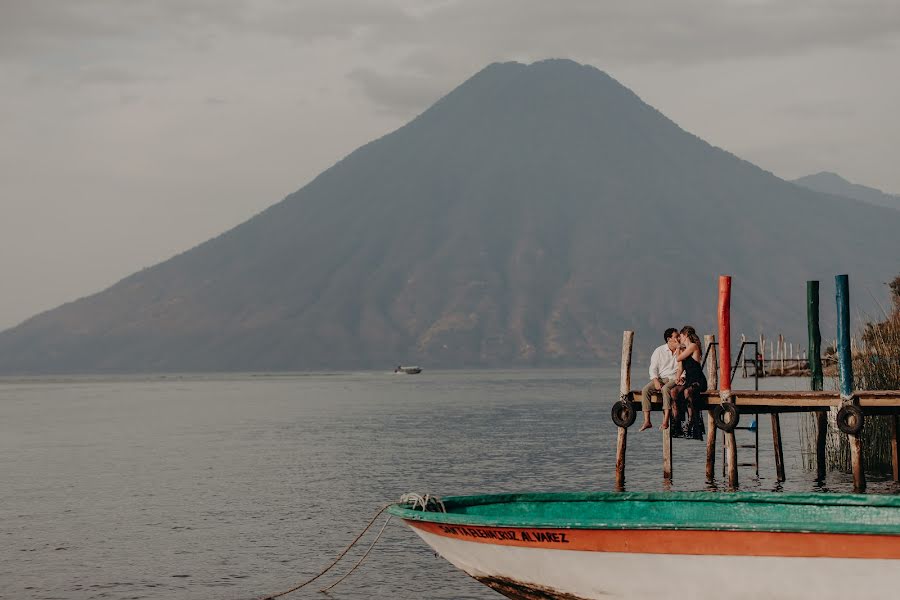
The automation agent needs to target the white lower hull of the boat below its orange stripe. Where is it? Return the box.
[408,522,900,600]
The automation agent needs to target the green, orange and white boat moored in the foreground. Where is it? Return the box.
[389,492,900,600]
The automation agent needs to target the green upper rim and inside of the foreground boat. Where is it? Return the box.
[388,492,900,535]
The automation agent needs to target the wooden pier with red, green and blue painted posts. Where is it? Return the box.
[612,275,900,492]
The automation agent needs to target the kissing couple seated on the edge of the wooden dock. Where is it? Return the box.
[641,325,707,440]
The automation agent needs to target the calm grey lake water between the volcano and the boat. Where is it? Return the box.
[0,369,898,600]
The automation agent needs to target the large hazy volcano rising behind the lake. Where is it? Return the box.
[0,60,900,372]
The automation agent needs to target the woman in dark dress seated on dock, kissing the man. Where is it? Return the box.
[672,325,707,440]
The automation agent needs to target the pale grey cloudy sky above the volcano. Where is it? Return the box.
[0,0,900,329]
